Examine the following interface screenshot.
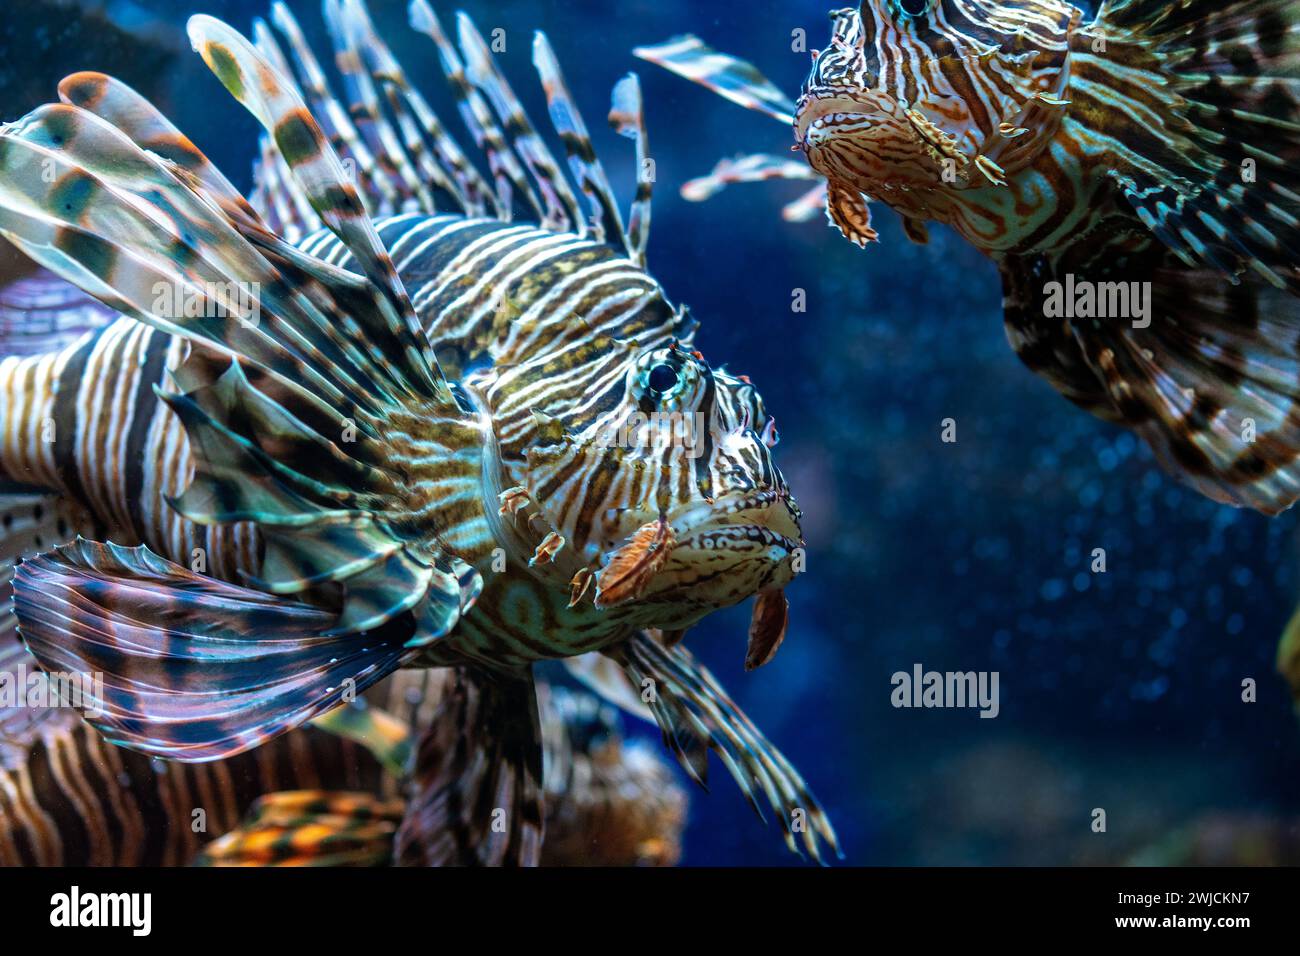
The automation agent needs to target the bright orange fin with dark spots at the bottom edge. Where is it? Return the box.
[194,790,406,866]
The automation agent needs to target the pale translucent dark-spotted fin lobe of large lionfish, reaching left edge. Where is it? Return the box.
[0,98,416,414]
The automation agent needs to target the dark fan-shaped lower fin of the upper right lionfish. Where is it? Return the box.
[1002,246,1300,514]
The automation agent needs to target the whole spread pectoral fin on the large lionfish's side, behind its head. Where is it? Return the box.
[0,74,481,640]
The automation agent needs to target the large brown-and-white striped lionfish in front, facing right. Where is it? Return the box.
[0,0,839,865]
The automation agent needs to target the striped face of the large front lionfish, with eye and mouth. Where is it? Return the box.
[573,342,803,662]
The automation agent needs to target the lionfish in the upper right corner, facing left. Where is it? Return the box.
[637,0,1300,514]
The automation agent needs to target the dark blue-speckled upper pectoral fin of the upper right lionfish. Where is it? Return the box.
[1071,0,1300,294]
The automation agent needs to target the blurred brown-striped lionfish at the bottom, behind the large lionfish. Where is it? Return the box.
[0,658,686,866]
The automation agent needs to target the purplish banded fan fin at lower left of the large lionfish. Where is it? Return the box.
[14,538,410,762]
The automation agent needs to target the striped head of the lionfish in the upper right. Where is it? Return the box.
[794,0,1080,202]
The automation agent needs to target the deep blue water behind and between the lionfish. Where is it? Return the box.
[4,0,1300,865]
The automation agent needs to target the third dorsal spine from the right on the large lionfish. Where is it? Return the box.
[456,13,582,233]
